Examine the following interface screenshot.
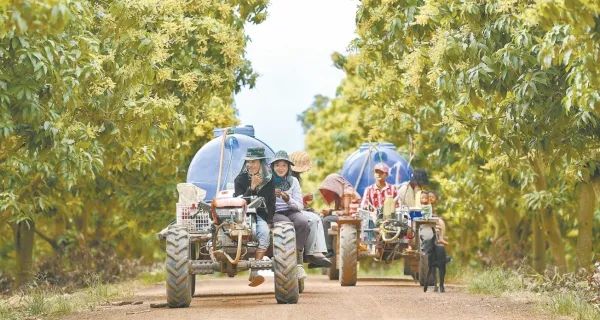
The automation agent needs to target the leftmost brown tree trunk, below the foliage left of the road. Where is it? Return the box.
[14,220,35,288]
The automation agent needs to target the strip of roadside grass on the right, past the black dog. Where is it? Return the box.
[465,268,600,320]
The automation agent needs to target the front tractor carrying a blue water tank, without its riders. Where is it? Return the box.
[158,126,304,308]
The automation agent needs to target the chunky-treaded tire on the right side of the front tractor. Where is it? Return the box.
[273,222,300,304]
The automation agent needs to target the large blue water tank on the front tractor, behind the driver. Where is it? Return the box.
[187,126,275,201]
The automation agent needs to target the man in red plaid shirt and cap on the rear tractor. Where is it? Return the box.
[360,162,398,211]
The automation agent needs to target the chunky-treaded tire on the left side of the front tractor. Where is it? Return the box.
[165,225,192,308]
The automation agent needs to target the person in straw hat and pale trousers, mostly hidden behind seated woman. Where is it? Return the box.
[290,151,331,269]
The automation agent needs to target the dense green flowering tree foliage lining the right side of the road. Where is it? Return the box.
[305,0,600,271]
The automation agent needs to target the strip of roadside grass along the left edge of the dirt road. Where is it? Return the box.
[0,277,134,320]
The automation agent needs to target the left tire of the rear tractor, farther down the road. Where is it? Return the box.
[339,223,358,287]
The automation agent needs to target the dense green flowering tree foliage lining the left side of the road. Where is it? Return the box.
[0,0,267,284]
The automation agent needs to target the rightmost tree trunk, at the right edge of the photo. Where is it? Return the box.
[577,182,596,269]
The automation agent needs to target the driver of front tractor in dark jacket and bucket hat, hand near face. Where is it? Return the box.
[234,148,275,287]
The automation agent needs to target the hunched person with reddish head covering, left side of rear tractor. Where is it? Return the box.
[319,173,360,257]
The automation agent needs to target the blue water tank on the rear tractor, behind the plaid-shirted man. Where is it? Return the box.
[342,142,412,196]
